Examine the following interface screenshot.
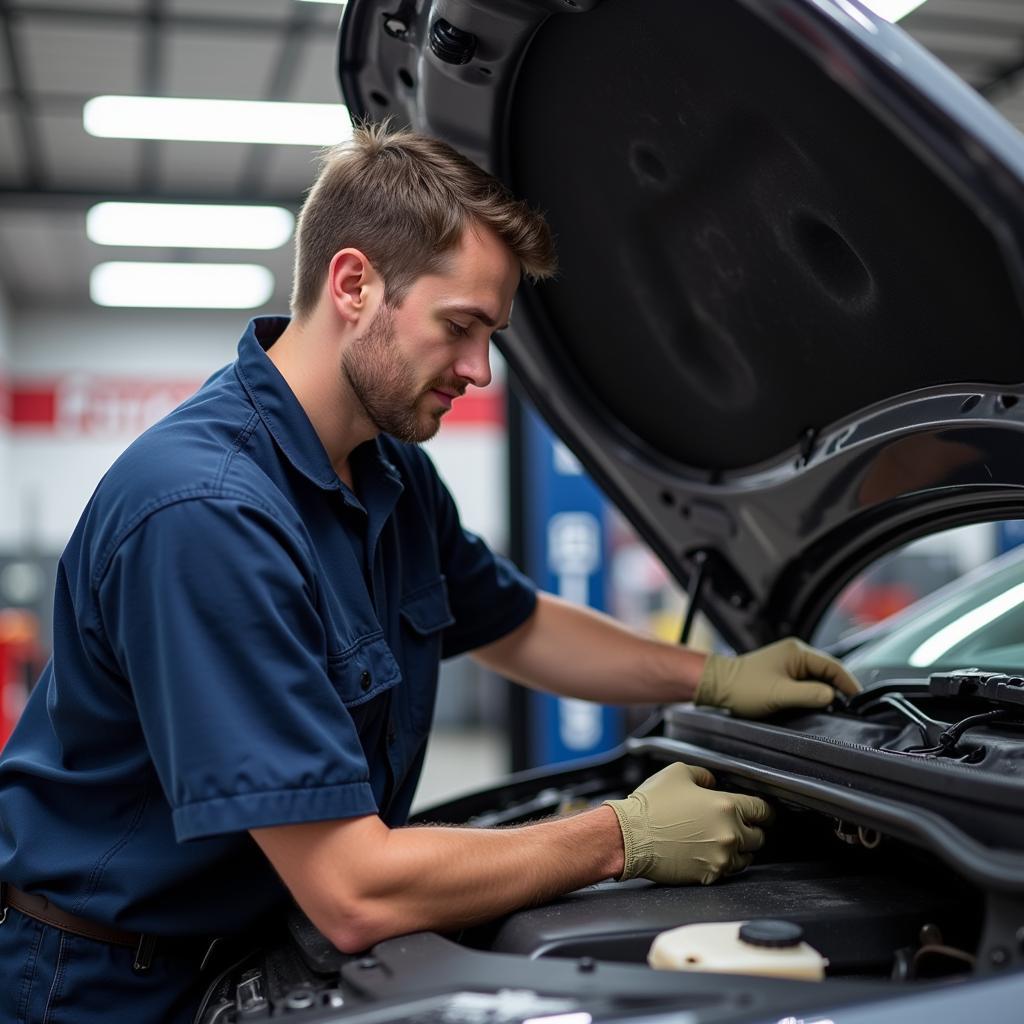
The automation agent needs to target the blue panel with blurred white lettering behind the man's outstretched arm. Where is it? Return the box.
[522,408,623,765]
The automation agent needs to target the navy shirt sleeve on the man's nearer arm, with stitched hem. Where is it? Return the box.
[95,497,377,842]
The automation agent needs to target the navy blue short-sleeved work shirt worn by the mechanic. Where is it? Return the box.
[0,317,536,935]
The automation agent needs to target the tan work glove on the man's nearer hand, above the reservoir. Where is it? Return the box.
[605,763,773,886]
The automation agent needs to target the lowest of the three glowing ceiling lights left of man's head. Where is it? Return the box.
[89,262,273,309]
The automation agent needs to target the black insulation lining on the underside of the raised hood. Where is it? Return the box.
[506,0,1024,471]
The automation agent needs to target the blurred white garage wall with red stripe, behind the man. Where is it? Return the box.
[0,309,507,554]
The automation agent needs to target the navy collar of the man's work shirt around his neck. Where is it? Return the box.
[236,316,401,504]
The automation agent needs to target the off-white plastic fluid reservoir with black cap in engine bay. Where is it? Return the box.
[647,921,828,981]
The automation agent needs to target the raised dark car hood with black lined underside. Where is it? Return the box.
[339,0,1024,648]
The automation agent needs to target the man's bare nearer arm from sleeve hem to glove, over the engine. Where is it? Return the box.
[253,807,623,952]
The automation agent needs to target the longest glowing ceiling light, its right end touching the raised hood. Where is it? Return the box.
[82,96,352,145]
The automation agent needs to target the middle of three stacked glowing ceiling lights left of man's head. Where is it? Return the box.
[85,203,295,249]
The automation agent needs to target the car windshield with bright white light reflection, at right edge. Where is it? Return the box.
[845,549,1024,685]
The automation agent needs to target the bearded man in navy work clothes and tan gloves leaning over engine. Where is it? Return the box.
[0,127,857,1024]
